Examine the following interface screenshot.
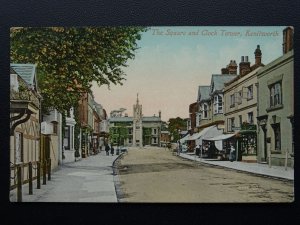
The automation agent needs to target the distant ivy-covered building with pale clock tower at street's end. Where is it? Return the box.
[109,96,162,147]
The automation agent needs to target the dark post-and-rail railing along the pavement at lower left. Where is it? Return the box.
[10,158,51,202]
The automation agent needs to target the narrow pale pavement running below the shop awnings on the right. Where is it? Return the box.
[179,153,294,180]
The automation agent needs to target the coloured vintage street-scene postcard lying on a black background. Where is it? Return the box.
[9,26,294,203]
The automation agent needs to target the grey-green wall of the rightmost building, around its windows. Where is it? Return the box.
[258,51,294,166]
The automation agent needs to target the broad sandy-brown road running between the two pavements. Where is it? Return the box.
[117,147,294,203]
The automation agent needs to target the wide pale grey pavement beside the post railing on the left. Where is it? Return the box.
[9,151,121,203]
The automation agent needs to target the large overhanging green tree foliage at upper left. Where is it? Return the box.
[10,27,146,112]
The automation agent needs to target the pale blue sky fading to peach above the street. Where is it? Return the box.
[93,26,285,121]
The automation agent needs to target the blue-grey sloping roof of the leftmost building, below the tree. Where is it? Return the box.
[10,64,37,87]
